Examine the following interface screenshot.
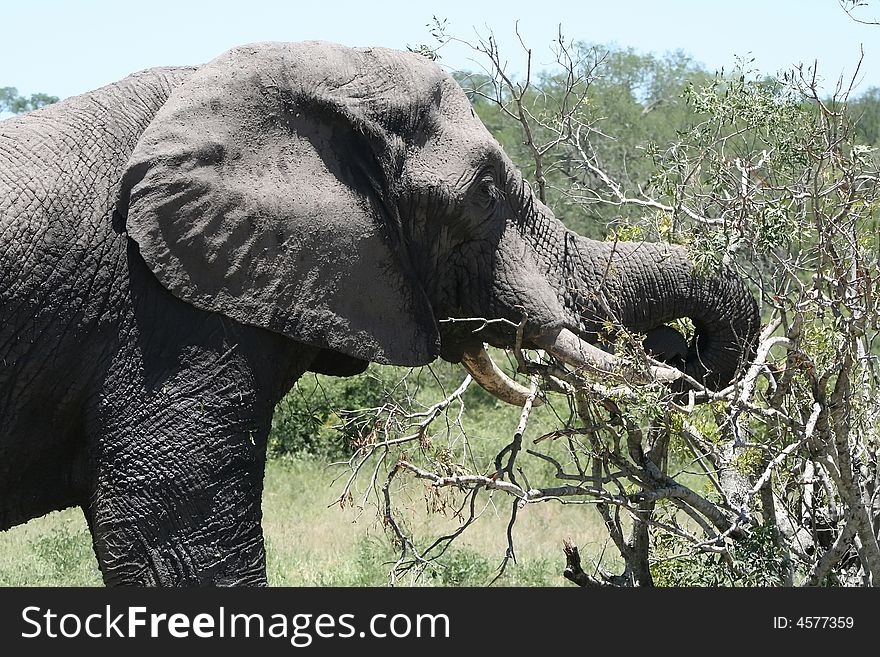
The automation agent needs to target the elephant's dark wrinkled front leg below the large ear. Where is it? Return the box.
[84,243,318,586]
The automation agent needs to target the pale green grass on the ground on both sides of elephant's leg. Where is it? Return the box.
[0,457,604,586]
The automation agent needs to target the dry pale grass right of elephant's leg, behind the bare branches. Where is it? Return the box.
[263,459,616,586]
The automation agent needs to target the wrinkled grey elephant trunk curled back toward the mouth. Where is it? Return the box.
[561,232,760,389]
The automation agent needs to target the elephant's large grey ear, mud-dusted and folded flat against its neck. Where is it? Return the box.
[117,44,439,365]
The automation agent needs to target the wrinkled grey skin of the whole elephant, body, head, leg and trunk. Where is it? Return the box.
[0,43,758,585]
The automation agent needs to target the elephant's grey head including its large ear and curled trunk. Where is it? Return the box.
[117,42,759,400]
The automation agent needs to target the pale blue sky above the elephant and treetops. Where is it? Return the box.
[0,0,880,97]
